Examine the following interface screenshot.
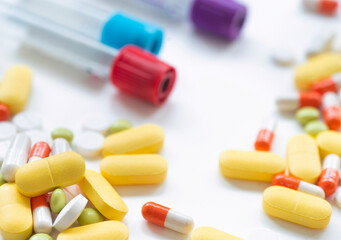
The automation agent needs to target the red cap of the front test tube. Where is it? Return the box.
[111,46,176,105]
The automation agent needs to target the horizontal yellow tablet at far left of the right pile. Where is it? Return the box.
[219,150,286,182]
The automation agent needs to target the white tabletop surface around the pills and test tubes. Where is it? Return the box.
[0,0,341,240]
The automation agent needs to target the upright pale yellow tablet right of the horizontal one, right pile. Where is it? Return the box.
[287,134,321,183]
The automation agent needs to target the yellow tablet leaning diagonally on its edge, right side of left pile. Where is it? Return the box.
[78,169,128,221]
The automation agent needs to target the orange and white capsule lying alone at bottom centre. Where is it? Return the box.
[142,202,194,234]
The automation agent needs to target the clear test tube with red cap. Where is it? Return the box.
[0,3,176,105]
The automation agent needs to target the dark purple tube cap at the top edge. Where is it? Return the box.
[191,0,247,41]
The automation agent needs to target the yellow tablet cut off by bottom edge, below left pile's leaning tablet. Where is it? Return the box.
[57,221,129,240]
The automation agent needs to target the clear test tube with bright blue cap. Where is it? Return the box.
[5,0,163,54]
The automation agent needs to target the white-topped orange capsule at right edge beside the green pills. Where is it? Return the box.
[322,92,341,131]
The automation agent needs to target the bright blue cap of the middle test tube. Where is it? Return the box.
[101,13,163,54]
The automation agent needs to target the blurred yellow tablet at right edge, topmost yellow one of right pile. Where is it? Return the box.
[295,53,341,90]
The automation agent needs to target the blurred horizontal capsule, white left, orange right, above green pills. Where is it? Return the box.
[276,92,322,113]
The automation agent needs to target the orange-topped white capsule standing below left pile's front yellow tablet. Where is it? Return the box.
[31,194,52,233]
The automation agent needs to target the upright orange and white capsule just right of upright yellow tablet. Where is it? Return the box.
[318,154,341,196]
